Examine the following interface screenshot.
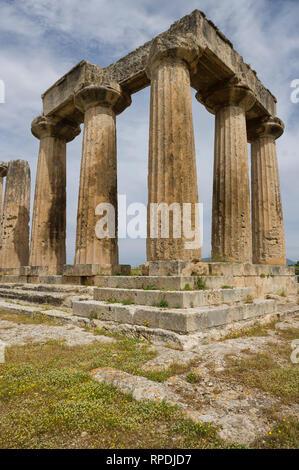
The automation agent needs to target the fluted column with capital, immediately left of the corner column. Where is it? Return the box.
[75,84,131,266]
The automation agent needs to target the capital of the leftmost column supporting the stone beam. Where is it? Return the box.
[31,116,81,142]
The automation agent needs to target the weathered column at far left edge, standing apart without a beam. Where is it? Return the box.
[1,160,30,268]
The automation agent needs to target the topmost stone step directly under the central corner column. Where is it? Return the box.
[95,276,239,290]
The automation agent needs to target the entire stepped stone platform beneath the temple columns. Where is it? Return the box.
[0,261,298,348]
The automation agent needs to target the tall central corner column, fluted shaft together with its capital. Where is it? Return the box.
[146,36,201,261]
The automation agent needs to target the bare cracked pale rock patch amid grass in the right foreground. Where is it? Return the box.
[93,316,299,445]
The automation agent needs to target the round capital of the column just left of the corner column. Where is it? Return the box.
[74,83,132,114]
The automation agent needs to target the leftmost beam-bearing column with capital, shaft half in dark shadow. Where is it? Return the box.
[29,116,80,274]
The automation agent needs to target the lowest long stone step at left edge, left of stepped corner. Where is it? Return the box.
[0,288,83,307]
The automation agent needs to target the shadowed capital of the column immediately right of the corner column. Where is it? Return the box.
[196,75,256,114]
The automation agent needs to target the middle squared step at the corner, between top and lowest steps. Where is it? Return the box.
[94,287,253,308]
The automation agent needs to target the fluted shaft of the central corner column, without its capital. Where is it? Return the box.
[147,57,201,260]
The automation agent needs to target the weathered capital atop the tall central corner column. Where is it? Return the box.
[145,34,203,78]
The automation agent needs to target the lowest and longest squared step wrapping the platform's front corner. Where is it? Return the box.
[73,299,277,334]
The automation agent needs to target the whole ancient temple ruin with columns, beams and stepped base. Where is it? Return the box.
[1,10,296,342]
